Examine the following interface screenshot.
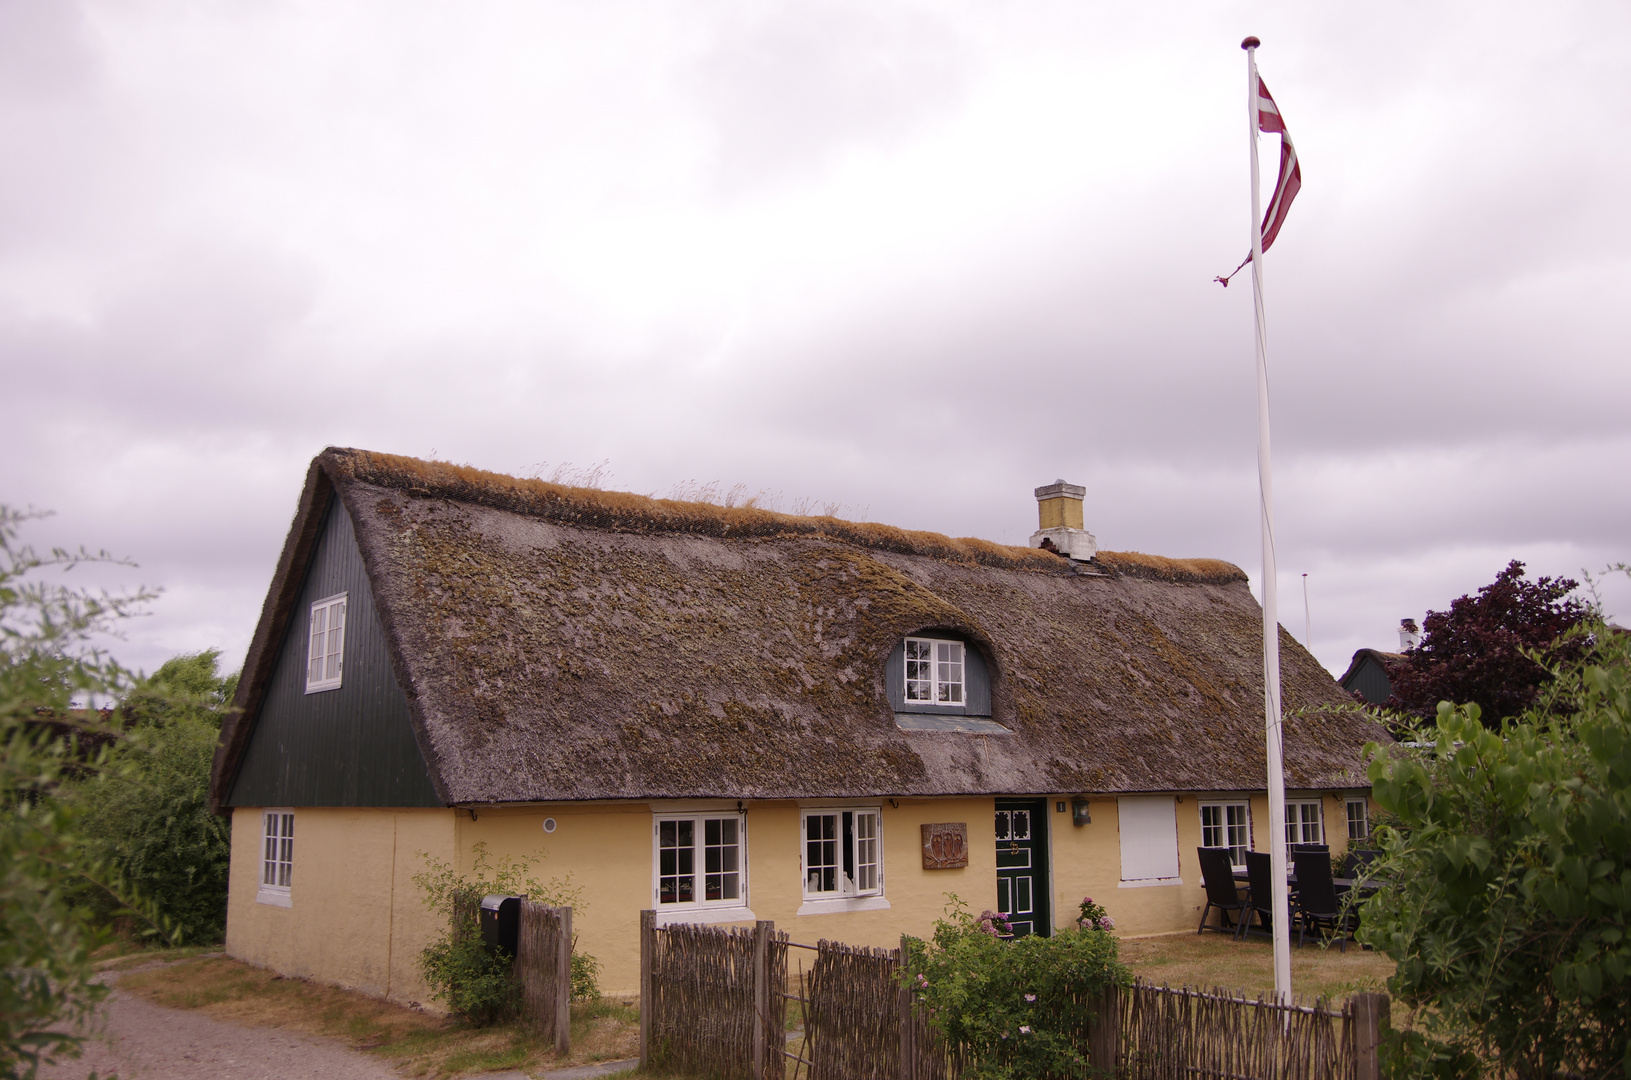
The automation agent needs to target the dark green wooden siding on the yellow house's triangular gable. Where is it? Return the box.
[227,499,442,806]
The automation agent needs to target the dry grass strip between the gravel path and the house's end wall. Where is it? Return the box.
[114,953,639,1078]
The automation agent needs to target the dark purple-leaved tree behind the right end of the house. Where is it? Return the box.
[1386,560,1590,726]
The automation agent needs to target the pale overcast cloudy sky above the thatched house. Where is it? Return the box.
[0,0,1631,685]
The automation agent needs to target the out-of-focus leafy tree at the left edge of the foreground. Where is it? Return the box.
[0,506,161,1078]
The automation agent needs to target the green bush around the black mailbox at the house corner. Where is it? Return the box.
[414,842,599,1028]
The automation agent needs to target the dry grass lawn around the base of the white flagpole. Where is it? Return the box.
[1120,933,1395,1002]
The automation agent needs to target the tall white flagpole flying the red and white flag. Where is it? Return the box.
[1240,38,1292,1003]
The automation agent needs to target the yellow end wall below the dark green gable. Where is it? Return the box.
[227,808,455,1003]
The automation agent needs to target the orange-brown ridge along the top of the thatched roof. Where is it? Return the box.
[321,447,1246,584]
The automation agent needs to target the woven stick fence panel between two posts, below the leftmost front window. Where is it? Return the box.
[639,910,788,1080]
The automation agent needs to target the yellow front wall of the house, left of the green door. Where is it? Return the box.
[457,799,997,995]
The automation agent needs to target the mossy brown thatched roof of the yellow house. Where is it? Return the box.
[212,449,1386,806]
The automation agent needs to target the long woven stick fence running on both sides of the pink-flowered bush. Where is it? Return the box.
[639,910,1388,1080]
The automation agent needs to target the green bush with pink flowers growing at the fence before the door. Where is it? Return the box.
[905,896,1132,1080]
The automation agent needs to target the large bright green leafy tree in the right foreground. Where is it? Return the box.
[1360,623,1631,1078]
